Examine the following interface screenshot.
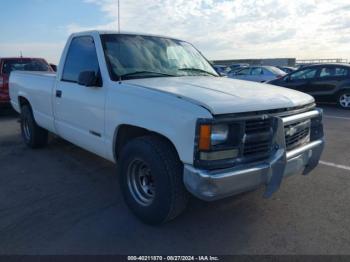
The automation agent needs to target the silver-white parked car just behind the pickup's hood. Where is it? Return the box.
[227,66,286,83]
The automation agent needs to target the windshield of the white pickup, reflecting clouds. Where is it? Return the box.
[101,34,218,81]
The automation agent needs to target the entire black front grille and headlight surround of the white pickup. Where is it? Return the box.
[195,105,323,170]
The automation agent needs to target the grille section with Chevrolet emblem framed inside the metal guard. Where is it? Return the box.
[284,120,311,151]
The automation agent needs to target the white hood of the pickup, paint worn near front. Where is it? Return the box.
[125,76,314,115]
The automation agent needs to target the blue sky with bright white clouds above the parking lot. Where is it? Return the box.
[0,0,350,63]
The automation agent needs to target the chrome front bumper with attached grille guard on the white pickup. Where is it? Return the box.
[184,110,324,201]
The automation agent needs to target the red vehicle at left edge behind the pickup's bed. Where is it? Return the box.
[0,57,53,107]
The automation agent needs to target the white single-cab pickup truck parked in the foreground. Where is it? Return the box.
[10,31,324,224]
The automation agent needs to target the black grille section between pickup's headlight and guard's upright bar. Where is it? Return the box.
[243,118,273,160]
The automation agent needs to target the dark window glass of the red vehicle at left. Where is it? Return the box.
[2,58,51,75]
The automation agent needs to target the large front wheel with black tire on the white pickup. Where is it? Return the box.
[118,136,188,225]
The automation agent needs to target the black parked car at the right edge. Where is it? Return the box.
[269,64,350,109]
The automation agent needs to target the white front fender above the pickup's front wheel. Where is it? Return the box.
[106,84,212,164]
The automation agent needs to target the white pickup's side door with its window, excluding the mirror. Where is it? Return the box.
[54,36,106,156]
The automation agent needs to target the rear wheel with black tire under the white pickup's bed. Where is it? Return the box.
[21,105,48,148]
